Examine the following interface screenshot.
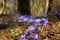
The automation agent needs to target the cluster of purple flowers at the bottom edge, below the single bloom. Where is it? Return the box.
[20,32,40,40]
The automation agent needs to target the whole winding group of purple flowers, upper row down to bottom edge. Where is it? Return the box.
[18,16,48,40]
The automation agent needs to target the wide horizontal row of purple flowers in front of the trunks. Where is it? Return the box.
[18,16,48,25]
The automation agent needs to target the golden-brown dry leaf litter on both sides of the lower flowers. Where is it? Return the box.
[0,22,60,40]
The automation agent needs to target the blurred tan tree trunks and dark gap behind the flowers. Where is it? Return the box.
[0,0,60,17]
